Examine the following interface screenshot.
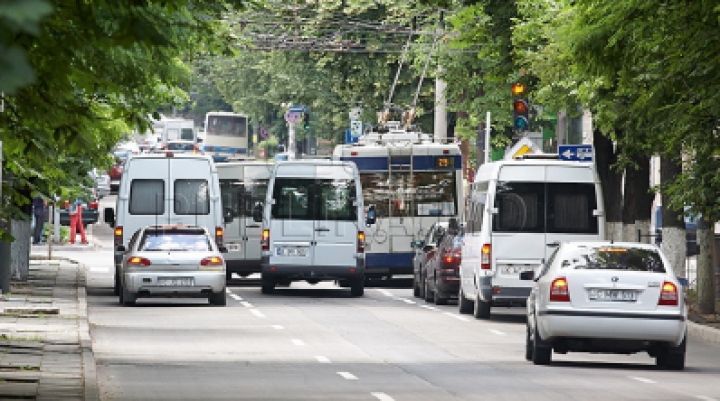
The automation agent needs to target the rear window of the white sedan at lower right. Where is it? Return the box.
[560,245,665,273]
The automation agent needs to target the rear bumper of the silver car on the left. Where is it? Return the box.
[123,271,225,296]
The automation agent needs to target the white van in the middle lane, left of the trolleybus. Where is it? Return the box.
[253,160,375,296]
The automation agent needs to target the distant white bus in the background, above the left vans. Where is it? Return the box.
[200,111,248,161]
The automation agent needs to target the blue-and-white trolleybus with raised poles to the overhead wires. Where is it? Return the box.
[333,121,464,278]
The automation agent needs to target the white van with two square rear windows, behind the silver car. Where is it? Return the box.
[104,152,223,295]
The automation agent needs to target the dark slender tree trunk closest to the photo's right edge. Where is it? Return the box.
[697,218,715,314]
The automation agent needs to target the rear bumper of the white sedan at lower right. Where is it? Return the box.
[537,310,687,345]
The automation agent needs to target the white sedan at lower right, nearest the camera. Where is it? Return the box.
[520,242,687,370]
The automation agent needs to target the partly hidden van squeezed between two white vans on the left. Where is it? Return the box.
[215,161,274,280]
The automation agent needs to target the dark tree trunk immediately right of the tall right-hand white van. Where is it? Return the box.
[593,129,622,241]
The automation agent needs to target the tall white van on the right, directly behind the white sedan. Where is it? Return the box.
[458,155,605,318]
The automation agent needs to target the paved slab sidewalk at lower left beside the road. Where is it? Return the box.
[0,256,99,401]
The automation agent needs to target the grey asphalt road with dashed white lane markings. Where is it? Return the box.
[54,195,720,401]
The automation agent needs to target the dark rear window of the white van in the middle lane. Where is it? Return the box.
[271,178,358,221]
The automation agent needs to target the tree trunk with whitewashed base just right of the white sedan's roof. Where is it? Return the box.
[660,157,687,277]
